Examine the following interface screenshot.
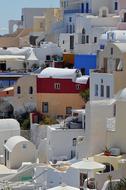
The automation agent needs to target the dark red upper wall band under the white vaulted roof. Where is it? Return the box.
[37,78,89,93]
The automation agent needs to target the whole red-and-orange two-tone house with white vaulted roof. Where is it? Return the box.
[37,68,89,117]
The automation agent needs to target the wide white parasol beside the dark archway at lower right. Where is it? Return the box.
[71,159,105,172]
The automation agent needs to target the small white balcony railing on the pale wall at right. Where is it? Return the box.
[106,117,116,132]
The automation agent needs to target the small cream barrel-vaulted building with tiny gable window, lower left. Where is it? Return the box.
[4,136,36,169]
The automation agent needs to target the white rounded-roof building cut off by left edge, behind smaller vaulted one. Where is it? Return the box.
[0,119,20,155]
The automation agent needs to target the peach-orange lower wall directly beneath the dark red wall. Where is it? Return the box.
[37,93,85,117]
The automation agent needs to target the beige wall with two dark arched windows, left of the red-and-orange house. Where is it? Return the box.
[11,75,36,112]
